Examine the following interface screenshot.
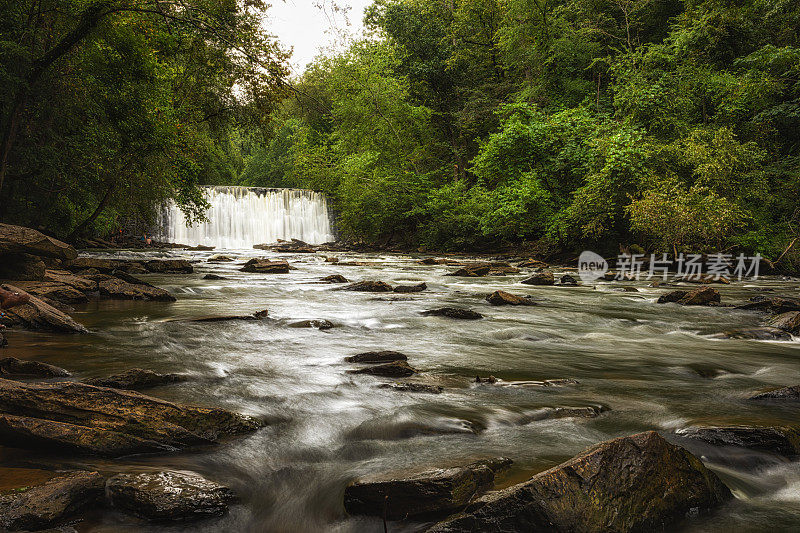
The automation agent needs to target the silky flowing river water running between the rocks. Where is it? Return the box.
[0,250,800,532]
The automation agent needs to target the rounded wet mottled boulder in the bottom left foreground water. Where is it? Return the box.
[106,471,237,521]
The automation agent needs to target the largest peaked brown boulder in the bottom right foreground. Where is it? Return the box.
[429,431,731,533]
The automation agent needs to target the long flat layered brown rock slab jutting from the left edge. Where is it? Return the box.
[0,379,262,457]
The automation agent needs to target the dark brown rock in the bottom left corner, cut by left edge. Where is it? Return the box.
[0,472,105,531]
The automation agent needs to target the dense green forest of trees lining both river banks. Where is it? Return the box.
[0,0,800,269]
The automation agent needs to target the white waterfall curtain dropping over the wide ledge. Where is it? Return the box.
[158,186,334,248]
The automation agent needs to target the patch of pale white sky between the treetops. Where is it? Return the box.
[264,0,372,74]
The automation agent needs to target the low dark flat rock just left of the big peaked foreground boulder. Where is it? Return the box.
[344,457,511,520]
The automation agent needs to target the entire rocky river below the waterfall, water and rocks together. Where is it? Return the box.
[0,225,800,532]
